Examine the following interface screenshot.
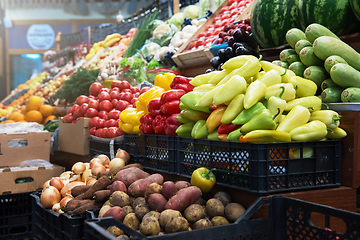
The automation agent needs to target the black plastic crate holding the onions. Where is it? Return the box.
[31,193,85,240]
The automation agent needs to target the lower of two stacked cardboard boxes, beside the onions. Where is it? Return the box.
[0,165,65,195]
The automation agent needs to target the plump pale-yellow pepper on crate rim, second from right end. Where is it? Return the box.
[290,120,328,141]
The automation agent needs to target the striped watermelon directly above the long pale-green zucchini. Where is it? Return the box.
[297,0,360,36]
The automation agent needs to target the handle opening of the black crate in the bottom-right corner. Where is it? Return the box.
[309,212,347,234]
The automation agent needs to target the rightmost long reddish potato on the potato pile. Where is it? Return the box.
[165,186,201,211]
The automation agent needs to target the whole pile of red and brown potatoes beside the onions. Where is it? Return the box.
[98,167,245,239]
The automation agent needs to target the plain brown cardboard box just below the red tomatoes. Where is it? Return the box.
[59,118,90,156]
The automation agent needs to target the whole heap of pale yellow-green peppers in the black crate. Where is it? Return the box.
[176,55,346,143]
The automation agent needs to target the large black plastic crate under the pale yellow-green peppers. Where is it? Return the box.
[176,138,341,194]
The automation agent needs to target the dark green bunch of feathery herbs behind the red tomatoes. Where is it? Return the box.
[55,68,100,103]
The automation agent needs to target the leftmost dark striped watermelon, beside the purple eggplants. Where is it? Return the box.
[250,0,297,48]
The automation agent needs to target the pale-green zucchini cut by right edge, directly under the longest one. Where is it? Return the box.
[330,63,360,87]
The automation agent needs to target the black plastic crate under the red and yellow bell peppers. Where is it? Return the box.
[124,133,177,173]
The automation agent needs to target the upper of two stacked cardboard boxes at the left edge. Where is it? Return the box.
[0,132,51,167]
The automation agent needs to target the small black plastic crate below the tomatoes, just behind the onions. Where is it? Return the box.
[89,138,123,157]
